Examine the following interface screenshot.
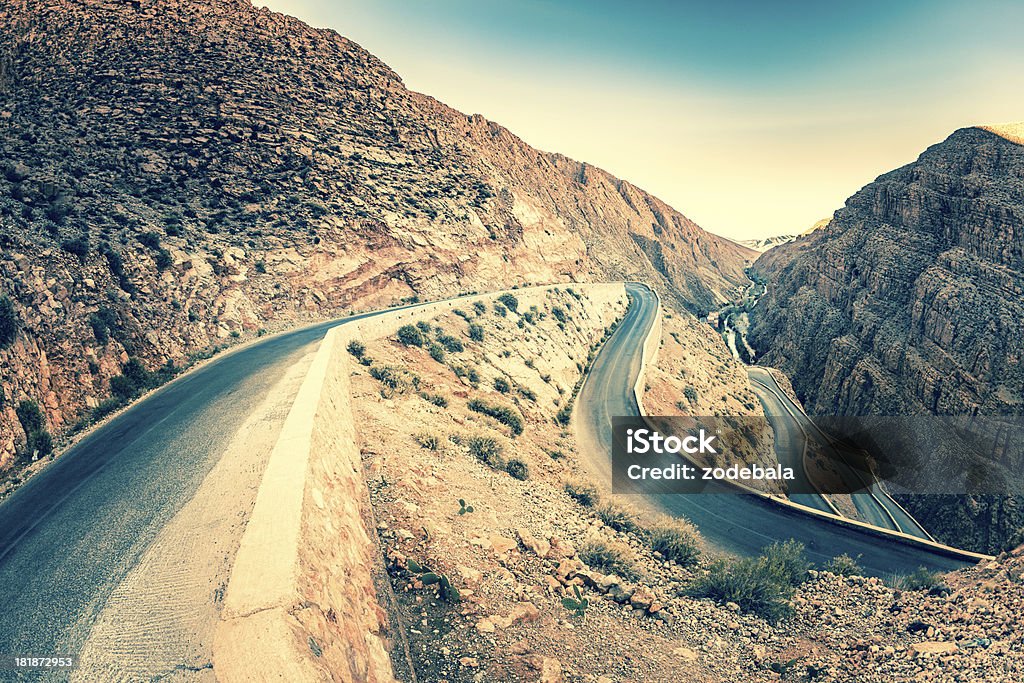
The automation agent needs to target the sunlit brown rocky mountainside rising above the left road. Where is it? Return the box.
[0,0,752,465]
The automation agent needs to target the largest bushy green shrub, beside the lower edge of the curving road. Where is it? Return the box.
[687,541,808,623]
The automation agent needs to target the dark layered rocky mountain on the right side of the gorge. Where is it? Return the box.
[751,128,1024,551]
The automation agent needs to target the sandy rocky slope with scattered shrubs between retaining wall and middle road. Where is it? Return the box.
[344,293,1024,682]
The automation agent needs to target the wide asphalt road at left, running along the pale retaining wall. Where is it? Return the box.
[0,305,419,680]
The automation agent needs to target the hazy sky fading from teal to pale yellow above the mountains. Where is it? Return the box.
[260,0,1024,239]
